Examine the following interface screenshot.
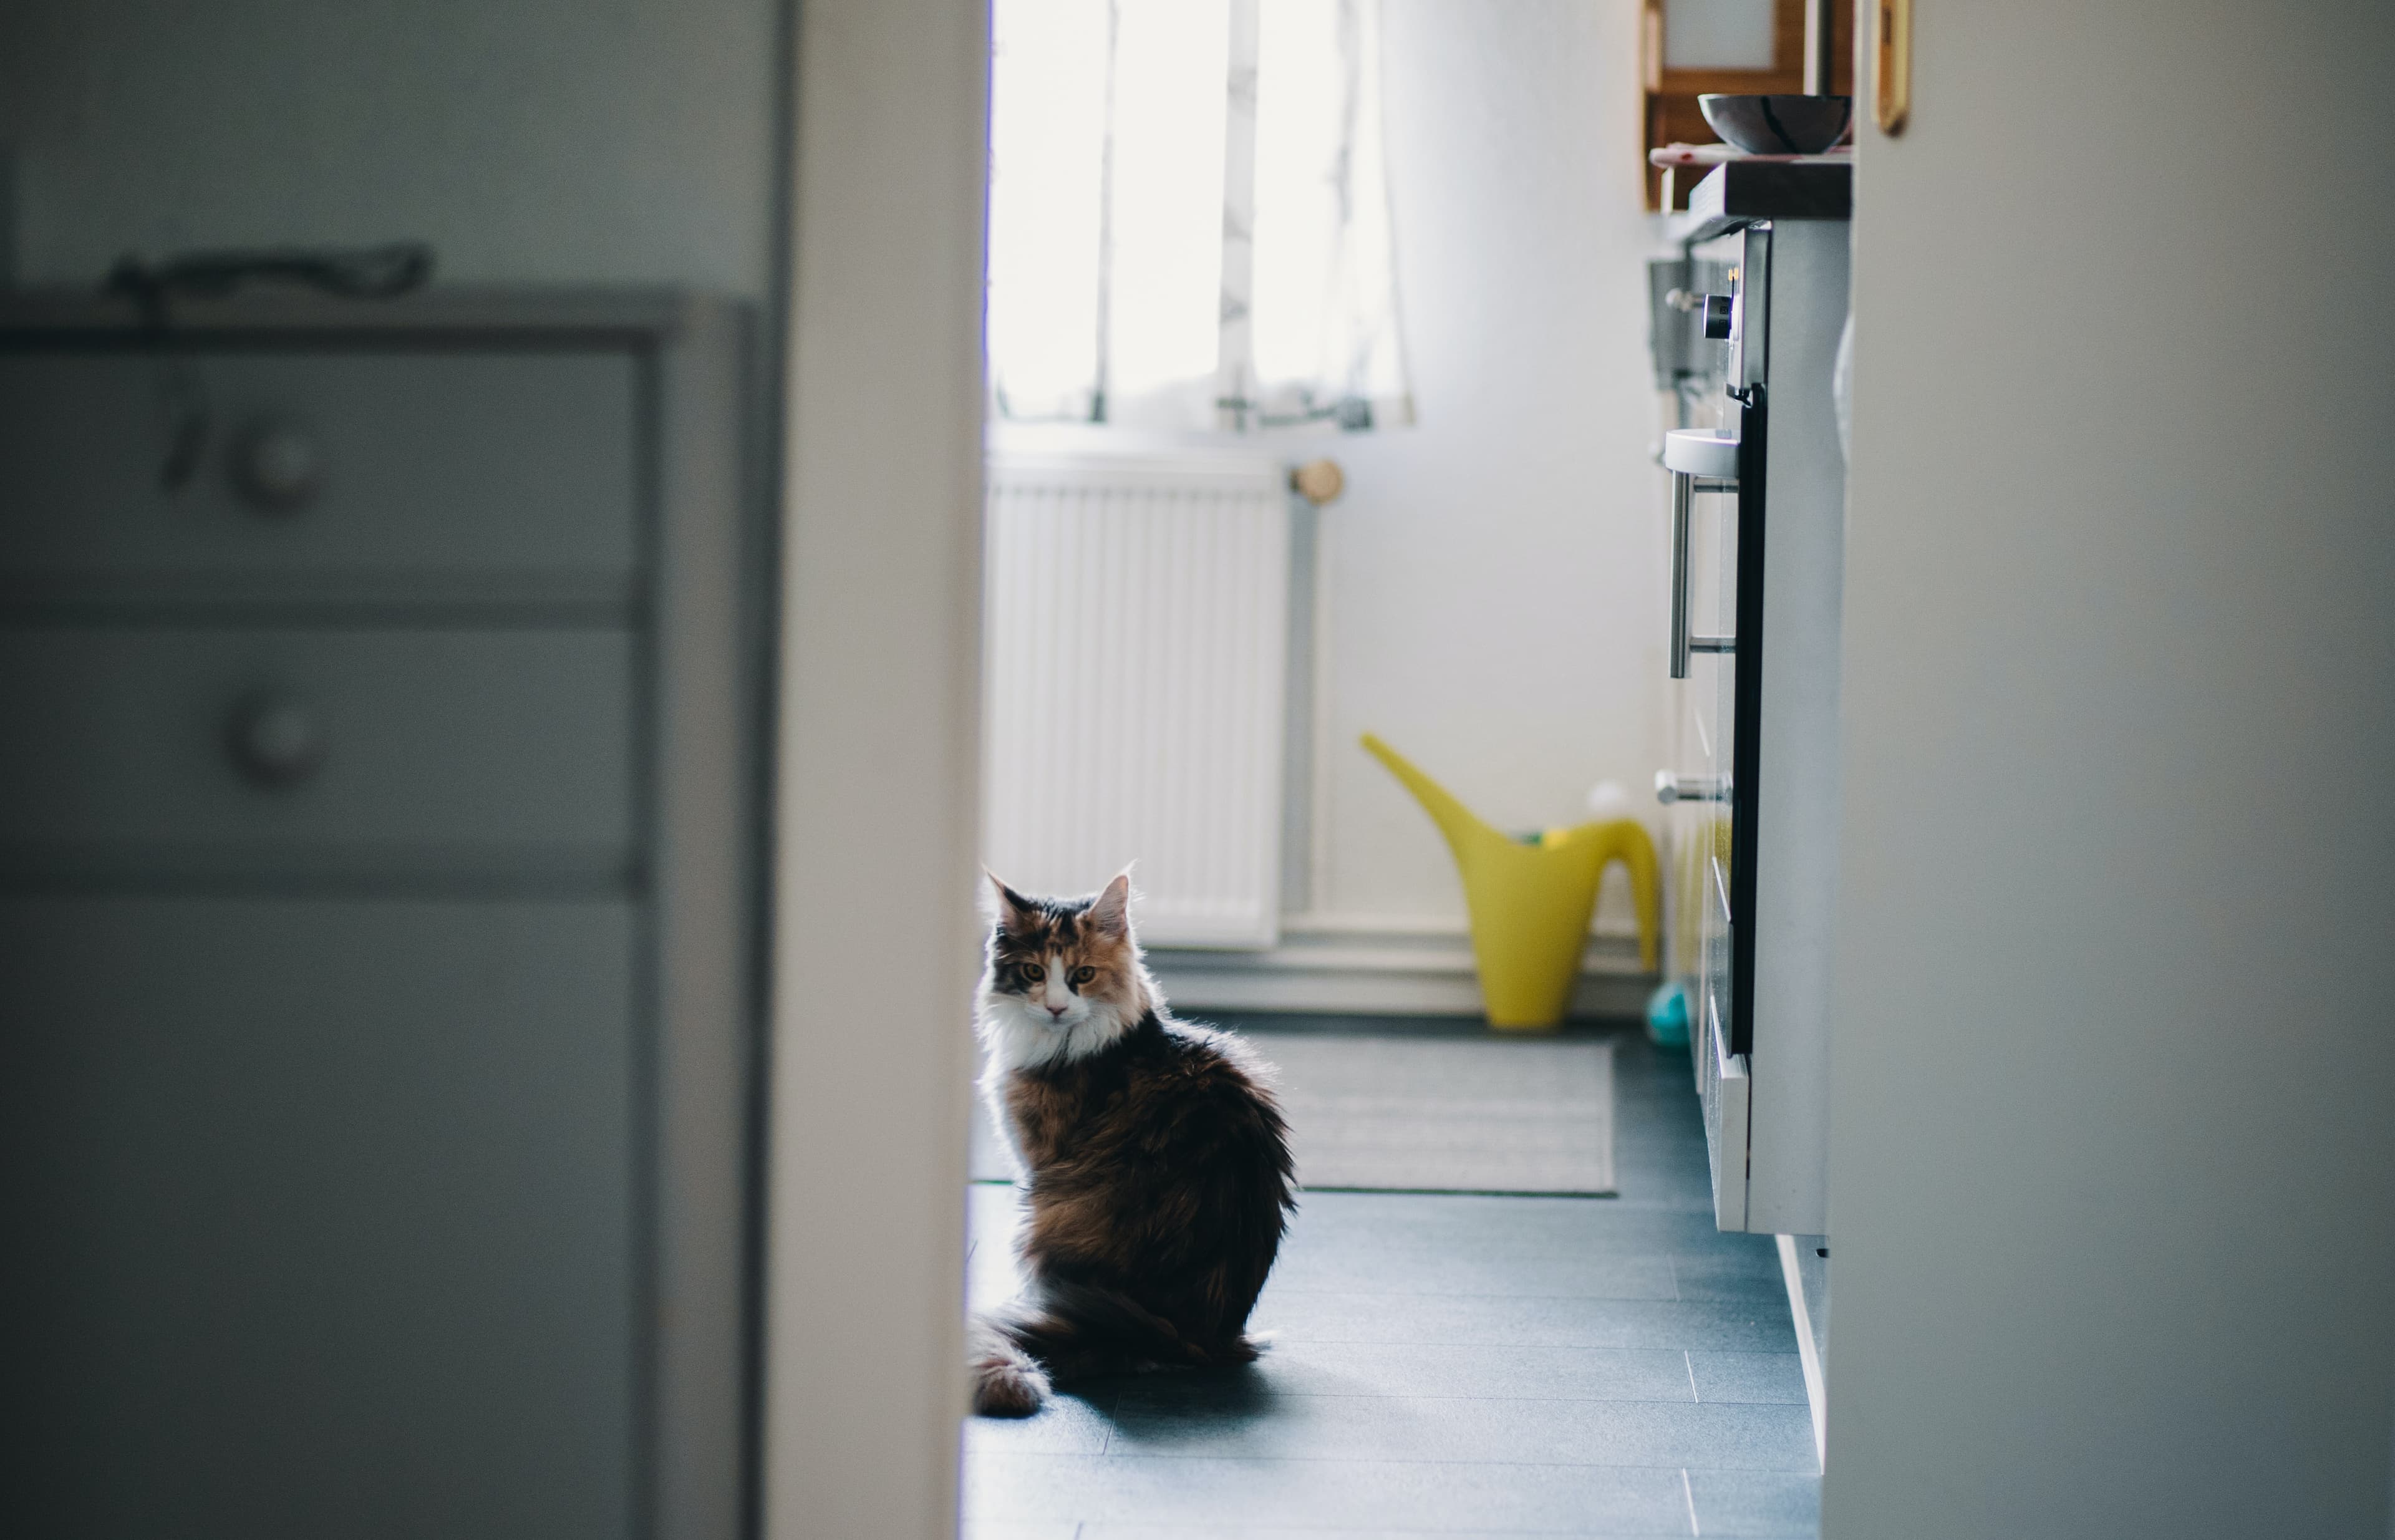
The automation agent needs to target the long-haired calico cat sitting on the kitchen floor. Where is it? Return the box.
[970,872,1295,1418]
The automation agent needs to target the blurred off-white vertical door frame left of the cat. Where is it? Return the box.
[757,0,989,1540]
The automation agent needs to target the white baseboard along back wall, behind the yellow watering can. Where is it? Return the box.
[1147,924,1655,1015]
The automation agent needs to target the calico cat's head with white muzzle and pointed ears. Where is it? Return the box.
[982,872,1147,1061]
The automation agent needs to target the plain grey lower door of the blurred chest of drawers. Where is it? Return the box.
[0,896,647,1540]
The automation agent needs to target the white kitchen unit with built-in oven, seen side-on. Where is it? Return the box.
[1655,163,1849,1236]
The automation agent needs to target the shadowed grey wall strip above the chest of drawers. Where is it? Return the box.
[0,0,781,297]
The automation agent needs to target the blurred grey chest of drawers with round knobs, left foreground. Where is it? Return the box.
[0,294,764,1540]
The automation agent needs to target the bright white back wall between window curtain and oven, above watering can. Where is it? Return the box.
[1315,0,1665,929]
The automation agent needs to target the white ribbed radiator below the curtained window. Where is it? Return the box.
[982,455,1289,946]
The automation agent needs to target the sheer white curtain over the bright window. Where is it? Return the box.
[989,0,1413,433]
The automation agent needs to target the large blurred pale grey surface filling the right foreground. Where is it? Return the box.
[1822,0,2395,1540]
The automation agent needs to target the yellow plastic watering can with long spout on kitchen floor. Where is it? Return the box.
[1363,733,1662,1027]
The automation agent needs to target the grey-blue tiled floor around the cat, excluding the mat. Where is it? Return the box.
[965,1023,1820,1540]
